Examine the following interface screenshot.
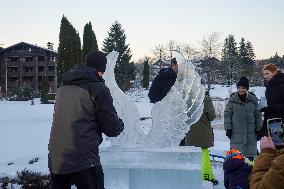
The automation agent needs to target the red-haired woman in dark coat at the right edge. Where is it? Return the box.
[258,64,284,139]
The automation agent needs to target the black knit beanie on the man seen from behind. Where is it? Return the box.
[85,51,107,72]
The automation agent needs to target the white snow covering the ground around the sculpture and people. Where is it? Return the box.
[0,85,265,188]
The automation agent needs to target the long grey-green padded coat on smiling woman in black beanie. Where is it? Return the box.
[224,92,262,156]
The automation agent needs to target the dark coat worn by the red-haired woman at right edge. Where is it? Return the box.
[260,72,284,136]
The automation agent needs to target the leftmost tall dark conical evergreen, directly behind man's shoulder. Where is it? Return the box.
[57,15,82,85]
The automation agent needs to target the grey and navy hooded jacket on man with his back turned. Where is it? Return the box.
[48,65,123,174]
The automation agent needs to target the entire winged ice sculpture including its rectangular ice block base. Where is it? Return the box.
[100,52,204,189]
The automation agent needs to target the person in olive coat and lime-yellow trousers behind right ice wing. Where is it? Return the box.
[185,91,218,185]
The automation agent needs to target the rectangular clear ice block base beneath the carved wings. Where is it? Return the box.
[100,147,202,189]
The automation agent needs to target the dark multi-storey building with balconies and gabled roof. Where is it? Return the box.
[0,42,57,94]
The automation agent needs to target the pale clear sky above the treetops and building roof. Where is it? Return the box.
[0,0,284,60]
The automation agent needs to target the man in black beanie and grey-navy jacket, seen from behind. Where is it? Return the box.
[48,51,124,189]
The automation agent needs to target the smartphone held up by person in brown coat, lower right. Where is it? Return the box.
[267,118,284,146]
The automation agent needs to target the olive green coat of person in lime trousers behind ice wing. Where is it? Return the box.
[185,95,216,148]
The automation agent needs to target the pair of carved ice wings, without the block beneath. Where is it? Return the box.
[104,51,205,148]
